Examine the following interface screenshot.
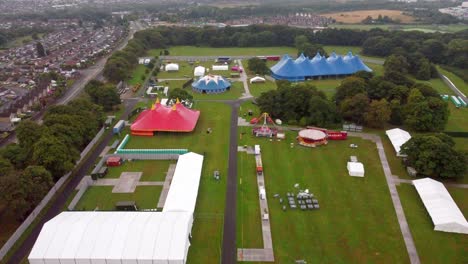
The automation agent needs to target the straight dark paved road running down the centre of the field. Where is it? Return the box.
[221,101,240,264]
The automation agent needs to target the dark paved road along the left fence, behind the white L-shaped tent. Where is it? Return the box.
[8,100,138,264]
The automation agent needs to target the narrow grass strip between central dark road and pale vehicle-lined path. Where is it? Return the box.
[236,152,263,248]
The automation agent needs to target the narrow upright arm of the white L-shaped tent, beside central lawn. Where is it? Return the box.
[163,152,203,213]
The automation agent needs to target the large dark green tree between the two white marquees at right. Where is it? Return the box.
[401,135,468,178]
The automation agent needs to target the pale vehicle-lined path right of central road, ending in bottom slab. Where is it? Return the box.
[237,148,275,262]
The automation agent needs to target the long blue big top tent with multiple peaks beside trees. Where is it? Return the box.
[270,52,372,82]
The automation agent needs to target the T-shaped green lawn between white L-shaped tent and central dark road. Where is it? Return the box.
[126,102,231,263]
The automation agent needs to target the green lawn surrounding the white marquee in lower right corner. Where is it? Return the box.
[398,184,468,263]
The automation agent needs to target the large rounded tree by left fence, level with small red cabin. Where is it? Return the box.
[33,134,79,181]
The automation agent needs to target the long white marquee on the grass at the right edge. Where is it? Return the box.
[413,178,468,234]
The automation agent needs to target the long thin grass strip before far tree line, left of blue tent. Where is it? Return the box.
[149,46,297,56]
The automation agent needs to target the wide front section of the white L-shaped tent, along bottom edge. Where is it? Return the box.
[28,212,193,264]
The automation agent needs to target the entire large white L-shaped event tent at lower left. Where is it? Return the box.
[28,152,203,264]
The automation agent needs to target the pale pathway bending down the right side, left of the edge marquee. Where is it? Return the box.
[348,132,420,264]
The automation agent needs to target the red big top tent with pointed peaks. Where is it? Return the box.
[130,100,200,136]
